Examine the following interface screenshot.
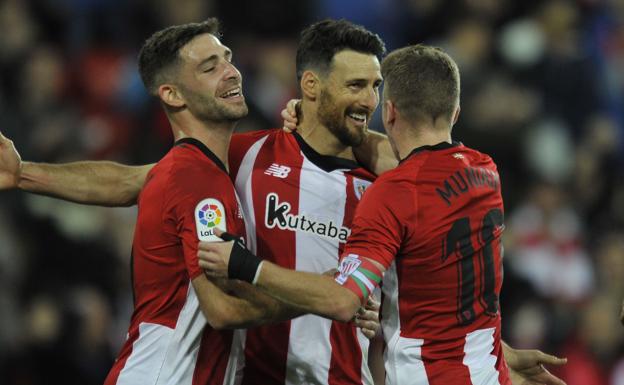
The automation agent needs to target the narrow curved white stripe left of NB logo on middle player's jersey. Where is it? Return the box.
[234,135,268,254]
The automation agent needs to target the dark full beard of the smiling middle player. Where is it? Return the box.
[318,90,368,147]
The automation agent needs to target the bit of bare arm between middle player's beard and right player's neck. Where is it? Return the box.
[353,130,399,175]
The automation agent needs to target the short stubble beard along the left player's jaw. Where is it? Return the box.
[184,85,249,122]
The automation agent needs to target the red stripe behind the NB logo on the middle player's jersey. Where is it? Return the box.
[243,131,303,385]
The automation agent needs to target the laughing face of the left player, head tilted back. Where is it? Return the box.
[175,33,248,122]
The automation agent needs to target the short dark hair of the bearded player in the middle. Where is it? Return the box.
[296,19,386,80]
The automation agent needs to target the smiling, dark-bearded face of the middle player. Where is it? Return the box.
[318,50,382,146]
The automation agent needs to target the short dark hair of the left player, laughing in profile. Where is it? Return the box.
[139,17,219,95]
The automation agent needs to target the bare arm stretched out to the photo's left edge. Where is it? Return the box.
[0,130,153,206]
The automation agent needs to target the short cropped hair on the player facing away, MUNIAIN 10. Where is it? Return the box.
[381,44,460,120]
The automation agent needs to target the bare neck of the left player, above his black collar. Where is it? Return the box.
[170,119,236,171]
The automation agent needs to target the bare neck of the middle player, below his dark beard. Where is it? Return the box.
[297,101,355,160]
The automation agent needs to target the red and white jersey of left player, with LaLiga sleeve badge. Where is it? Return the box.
[105,138,245,385]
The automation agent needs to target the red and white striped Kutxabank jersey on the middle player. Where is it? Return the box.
[229,130,374,385]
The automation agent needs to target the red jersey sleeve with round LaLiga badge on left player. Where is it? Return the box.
[165,165,236,279]
